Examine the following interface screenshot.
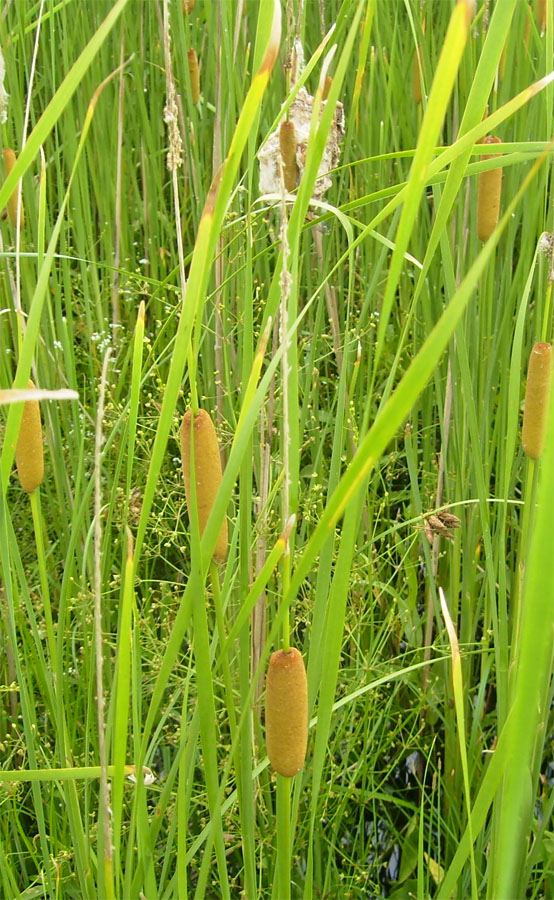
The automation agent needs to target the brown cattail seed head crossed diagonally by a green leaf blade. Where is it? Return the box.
[181,409,227,563]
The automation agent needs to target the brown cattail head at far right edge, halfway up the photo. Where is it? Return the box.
[522,342,552,459]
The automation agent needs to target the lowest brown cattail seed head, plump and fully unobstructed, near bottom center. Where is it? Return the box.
[265,647,308,778]
